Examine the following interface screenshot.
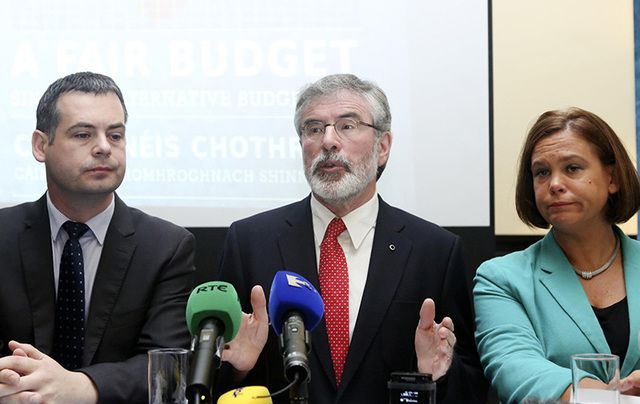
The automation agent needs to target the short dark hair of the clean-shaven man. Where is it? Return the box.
[36,72,128,143]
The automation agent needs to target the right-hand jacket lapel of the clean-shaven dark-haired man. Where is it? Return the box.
[83,196,137,366]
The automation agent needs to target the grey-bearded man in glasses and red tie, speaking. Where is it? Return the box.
[220,74,487,404]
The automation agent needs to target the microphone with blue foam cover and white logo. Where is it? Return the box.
[269,271,324,384]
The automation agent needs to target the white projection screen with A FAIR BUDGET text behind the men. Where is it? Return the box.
[0,0,490,227]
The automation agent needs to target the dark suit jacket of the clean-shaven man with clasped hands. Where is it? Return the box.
[0,196,195,403]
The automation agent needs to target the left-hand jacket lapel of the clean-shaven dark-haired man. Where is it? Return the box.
[19,196,56,354]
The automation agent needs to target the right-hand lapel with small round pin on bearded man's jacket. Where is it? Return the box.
[339,198,412,394]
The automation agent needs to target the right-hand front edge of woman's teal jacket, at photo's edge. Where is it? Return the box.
[616,228,640,375]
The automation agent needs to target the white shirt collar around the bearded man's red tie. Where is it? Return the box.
[311,193,379,249]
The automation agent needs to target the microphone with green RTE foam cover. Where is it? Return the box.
[186,281,242,403]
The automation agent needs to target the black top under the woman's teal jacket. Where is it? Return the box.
[593,297,630,367]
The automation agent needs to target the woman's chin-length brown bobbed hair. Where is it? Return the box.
[516,107,640,229]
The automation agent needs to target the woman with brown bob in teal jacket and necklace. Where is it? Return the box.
[473,108,640,403]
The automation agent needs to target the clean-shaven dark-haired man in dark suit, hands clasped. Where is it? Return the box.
[0,73,194,403]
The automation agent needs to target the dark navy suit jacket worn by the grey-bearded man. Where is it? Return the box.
[219,197,487,404]
